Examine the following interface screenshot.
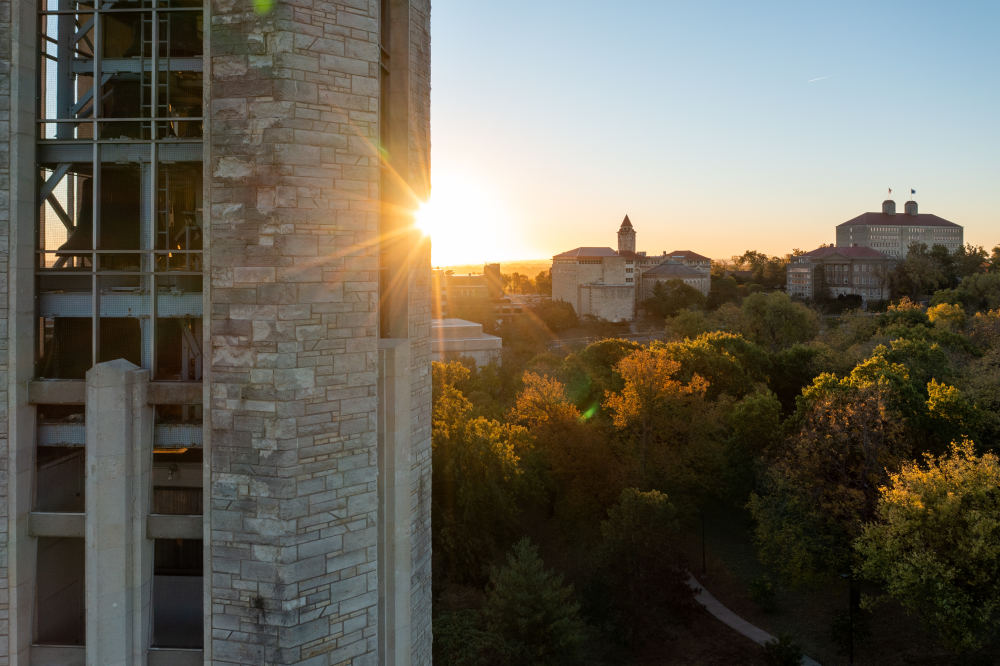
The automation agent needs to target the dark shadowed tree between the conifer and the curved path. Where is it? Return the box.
[588,488,694,646]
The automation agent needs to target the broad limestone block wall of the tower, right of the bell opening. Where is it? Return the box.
[206,0,379,666]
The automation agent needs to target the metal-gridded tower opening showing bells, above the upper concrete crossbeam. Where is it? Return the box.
[35,0,204,381]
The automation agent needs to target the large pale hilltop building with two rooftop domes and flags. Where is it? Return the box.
[837,199,965,259]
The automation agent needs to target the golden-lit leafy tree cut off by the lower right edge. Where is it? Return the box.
[857,440,1000,651]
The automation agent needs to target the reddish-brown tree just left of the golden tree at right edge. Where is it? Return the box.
[748,380,910,583]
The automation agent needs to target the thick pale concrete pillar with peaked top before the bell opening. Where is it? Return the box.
[85,359,153,666]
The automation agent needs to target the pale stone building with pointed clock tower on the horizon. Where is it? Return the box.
[552,215,712,321]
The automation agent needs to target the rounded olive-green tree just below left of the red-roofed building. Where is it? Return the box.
[740,293,820,351]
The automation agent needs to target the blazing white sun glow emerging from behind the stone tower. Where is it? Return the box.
[416,171,524,266]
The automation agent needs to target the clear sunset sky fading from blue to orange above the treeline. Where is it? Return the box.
[421,0,1000,265]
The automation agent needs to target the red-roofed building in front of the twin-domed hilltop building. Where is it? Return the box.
[786,247,899,302]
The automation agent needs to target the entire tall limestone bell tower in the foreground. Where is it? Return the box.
[0,0,431,666]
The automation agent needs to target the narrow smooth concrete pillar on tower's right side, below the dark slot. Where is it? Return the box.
[378,339,413,666]
